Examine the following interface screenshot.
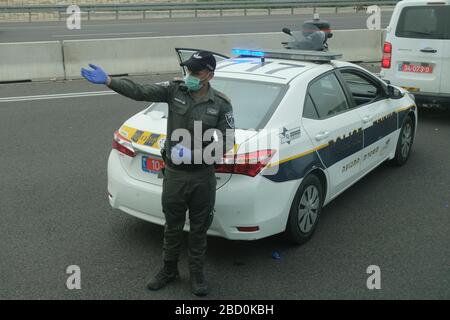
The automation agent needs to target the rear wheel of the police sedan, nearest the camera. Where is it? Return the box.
[285,174,324,245]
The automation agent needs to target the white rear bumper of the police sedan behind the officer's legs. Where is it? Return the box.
[108,150,297,240]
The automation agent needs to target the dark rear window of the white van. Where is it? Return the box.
[395,6,450,39]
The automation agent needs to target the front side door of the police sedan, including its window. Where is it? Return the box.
[338,68,397,174]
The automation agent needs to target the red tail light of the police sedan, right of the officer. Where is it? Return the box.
[216,150,276,177]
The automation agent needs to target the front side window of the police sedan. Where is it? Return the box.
[341,70,381,106]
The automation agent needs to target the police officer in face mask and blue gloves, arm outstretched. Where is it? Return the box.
[81,51,234,296]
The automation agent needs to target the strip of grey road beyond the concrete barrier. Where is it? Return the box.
[0,11,392,42]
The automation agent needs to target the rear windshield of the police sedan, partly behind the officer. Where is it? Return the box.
[148,77,286,130]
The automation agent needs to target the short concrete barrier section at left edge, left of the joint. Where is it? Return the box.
[0,41,64,82]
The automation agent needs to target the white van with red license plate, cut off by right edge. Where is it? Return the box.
[381,0,450,107]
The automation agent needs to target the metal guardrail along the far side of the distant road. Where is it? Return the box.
[0,0,399,21]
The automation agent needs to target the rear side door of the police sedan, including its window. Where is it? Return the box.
[302,71,363,197]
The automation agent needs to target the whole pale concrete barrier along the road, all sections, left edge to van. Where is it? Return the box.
[0,30,383,82]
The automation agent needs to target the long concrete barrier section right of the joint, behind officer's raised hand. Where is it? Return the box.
[63,30,382,79]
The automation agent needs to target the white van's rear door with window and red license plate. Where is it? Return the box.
[391,3,448,93]
